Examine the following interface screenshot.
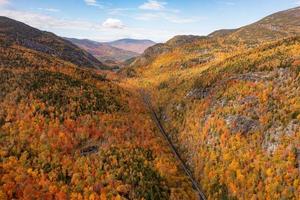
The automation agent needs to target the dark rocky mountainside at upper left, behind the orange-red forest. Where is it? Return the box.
[0,17,107,69]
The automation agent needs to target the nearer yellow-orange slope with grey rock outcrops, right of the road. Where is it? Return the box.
[158,38,300,199]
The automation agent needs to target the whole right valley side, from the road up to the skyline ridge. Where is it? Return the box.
[122,8,300,199]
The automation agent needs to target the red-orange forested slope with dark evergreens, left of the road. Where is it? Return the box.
[0,66,195,199]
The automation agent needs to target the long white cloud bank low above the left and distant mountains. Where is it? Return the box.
[0,9,197,42]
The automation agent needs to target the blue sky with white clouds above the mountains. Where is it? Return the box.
[0,0,300,42]
